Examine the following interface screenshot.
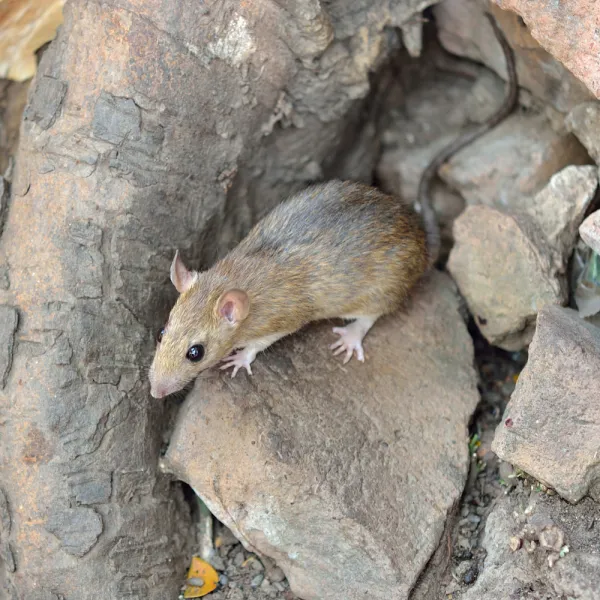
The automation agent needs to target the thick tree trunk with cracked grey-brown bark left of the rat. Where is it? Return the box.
[0,0,432,600]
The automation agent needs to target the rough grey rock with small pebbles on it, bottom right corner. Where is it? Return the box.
[462,489,600,600]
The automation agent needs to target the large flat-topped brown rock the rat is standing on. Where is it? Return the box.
[164,273,478,600]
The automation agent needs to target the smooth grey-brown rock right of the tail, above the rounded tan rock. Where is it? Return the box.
[439,113,590,209]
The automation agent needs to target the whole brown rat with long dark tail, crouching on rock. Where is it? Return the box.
[149,11,518,398]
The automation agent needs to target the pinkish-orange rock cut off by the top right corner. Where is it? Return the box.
[496,0,600,98]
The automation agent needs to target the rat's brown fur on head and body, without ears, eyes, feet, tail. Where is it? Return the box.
[151,181,429,387]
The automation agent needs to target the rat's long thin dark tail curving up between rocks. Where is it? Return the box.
[417,13,519,267]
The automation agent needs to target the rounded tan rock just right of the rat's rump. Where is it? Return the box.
[448,206,567,350]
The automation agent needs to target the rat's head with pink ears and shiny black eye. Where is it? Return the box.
[150,252,249,398]
